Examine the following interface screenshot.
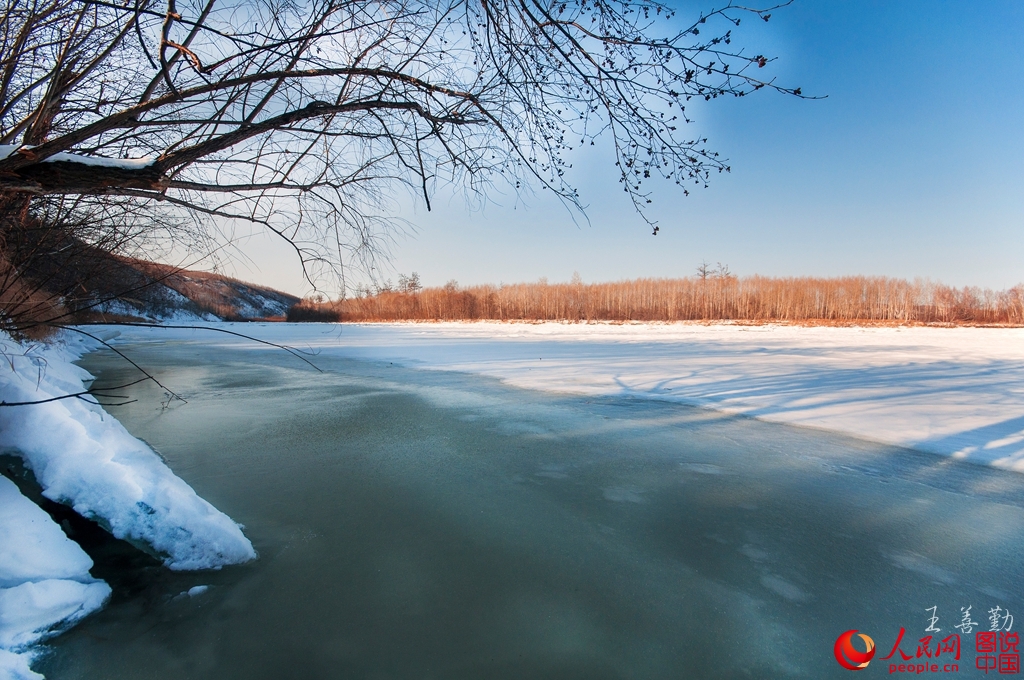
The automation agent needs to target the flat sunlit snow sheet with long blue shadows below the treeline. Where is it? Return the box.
[108,323,1024,472]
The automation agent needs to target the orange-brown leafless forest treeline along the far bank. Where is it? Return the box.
[289,275,1024,325]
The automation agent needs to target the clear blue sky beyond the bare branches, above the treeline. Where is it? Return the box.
[236,0,1024,293]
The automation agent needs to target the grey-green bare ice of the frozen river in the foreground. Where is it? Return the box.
[37,329,1024,680]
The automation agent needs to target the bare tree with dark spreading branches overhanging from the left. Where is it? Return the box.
[0,0,802,327]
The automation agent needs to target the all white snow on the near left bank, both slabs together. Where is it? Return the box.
[0,336,256,678]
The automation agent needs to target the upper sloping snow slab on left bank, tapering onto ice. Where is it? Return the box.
[0,331,256,569]
